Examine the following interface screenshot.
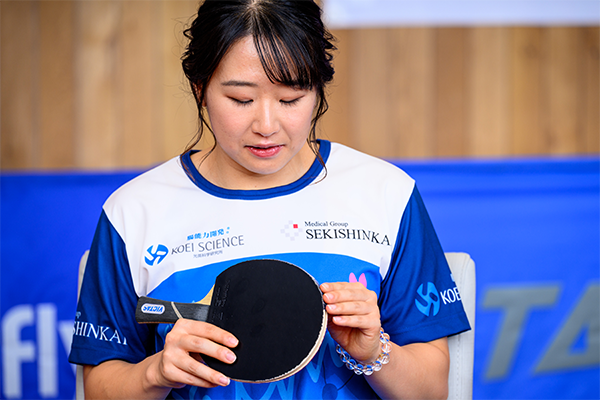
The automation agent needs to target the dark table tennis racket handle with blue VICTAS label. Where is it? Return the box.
[135,296,209,324]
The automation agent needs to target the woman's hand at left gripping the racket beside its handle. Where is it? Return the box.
[147,319,238,388]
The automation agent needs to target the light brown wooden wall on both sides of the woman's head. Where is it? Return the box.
[0,0,600,170]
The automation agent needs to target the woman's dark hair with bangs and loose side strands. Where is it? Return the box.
[182,0,335,162]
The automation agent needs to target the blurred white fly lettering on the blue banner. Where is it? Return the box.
[2,303,72,399]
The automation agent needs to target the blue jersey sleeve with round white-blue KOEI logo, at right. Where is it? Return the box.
[379,186,470,345]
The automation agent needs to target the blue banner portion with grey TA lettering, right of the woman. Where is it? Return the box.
[397,158,600,399]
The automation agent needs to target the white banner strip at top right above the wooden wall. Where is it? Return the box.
[323,0,600,29]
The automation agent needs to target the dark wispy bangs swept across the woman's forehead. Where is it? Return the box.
[254,30,320,90]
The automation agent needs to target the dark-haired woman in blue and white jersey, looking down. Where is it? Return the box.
[70,0,469,399]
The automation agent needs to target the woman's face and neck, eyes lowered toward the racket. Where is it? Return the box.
[200,37,316,189]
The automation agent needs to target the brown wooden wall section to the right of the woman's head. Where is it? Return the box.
[326,27,600,157]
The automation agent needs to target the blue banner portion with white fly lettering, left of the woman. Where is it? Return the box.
[0,173,135,399]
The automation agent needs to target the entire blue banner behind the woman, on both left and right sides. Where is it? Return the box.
[0,158,600,399]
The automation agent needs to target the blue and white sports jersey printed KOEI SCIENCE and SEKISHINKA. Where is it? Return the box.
[69,140,469,399]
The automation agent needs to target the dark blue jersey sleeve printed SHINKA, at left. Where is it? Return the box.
[69,212,153,365]
